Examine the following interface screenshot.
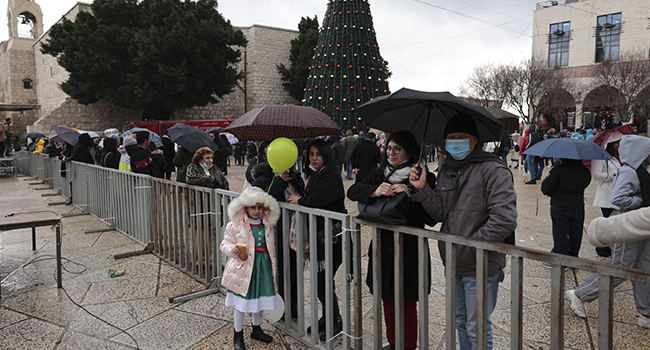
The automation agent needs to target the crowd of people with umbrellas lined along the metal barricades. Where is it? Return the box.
[17,117,650,349]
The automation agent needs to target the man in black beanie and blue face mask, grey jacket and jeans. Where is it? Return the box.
[409,112,517,349]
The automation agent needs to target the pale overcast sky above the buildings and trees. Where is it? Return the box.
[0,0,540,93]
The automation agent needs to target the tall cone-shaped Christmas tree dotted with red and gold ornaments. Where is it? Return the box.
[302,0,390,130]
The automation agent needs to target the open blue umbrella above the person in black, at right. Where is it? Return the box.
[524,137,611,160]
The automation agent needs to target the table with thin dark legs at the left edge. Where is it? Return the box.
[0,198,61,294]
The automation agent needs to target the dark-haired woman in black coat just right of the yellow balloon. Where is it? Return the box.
[289,139,347,341]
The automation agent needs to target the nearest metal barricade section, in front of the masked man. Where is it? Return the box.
[354,219,650,349]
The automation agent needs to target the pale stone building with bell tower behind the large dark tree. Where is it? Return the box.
[0,0,299,134]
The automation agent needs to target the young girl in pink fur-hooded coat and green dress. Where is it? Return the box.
[220,187,280,350]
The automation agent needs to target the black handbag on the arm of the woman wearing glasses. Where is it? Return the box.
[357,168,411,225]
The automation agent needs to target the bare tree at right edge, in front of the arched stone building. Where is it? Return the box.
[592,49,650,122]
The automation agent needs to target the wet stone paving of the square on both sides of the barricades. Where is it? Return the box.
[0,157,650,349]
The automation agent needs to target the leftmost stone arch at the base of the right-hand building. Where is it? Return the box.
[537,89,576,131]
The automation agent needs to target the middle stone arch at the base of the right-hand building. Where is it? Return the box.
[582,85,625,128]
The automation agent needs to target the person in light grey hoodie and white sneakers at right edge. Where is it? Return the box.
[565,135,650,328]
